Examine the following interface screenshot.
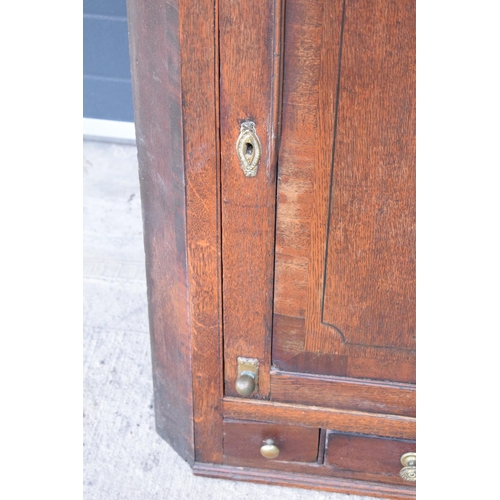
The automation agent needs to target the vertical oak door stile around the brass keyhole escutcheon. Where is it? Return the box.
[219,0,282,398]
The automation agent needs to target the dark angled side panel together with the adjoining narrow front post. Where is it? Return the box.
[127,0,222,465]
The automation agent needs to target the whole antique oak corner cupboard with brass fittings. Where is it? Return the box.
[128,0,416,499]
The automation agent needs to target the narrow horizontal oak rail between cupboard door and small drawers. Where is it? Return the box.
[223,398,416,439]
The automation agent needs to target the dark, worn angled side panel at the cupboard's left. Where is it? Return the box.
[127,0,194,463]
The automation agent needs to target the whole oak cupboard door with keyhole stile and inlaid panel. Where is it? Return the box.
[219,0,415,400]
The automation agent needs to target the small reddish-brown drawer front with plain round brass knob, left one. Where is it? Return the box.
[224,420,320,467]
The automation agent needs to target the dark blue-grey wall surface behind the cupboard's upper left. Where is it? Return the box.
[83,0,134,122]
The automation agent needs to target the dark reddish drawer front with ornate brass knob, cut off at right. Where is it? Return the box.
[325,431,416,486]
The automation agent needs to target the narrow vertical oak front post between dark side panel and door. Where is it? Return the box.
[179,0,223,462]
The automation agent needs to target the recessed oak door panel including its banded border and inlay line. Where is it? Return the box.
[273,0,415,376]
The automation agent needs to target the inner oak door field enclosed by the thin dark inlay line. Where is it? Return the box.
[322,0,415,349]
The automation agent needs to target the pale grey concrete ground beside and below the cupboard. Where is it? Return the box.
[83,142,382,500]
